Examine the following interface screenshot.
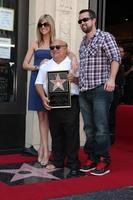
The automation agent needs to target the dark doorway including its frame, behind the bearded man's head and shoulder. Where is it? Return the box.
[88,0,133,51]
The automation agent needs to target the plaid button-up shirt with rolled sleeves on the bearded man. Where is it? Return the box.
[79,29,121,91]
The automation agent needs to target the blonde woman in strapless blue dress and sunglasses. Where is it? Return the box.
[23,14,55,165]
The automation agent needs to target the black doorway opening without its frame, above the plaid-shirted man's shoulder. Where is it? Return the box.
[105,0,133,54]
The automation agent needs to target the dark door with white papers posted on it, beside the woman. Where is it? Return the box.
[0,0,29,153]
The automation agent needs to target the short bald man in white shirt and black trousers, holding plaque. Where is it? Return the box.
[35,39,80,177]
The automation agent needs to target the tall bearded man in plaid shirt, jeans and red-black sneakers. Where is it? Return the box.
[78,9,121,176]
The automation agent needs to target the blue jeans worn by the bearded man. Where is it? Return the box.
[79,85,113,163]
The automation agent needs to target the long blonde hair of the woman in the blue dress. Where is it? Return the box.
[37,14,56,43]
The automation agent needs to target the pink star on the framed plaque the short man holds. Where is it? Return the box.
[50,73,66,92]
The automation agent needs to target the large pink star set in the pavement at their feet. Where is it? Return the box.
[0,163,60,182]
